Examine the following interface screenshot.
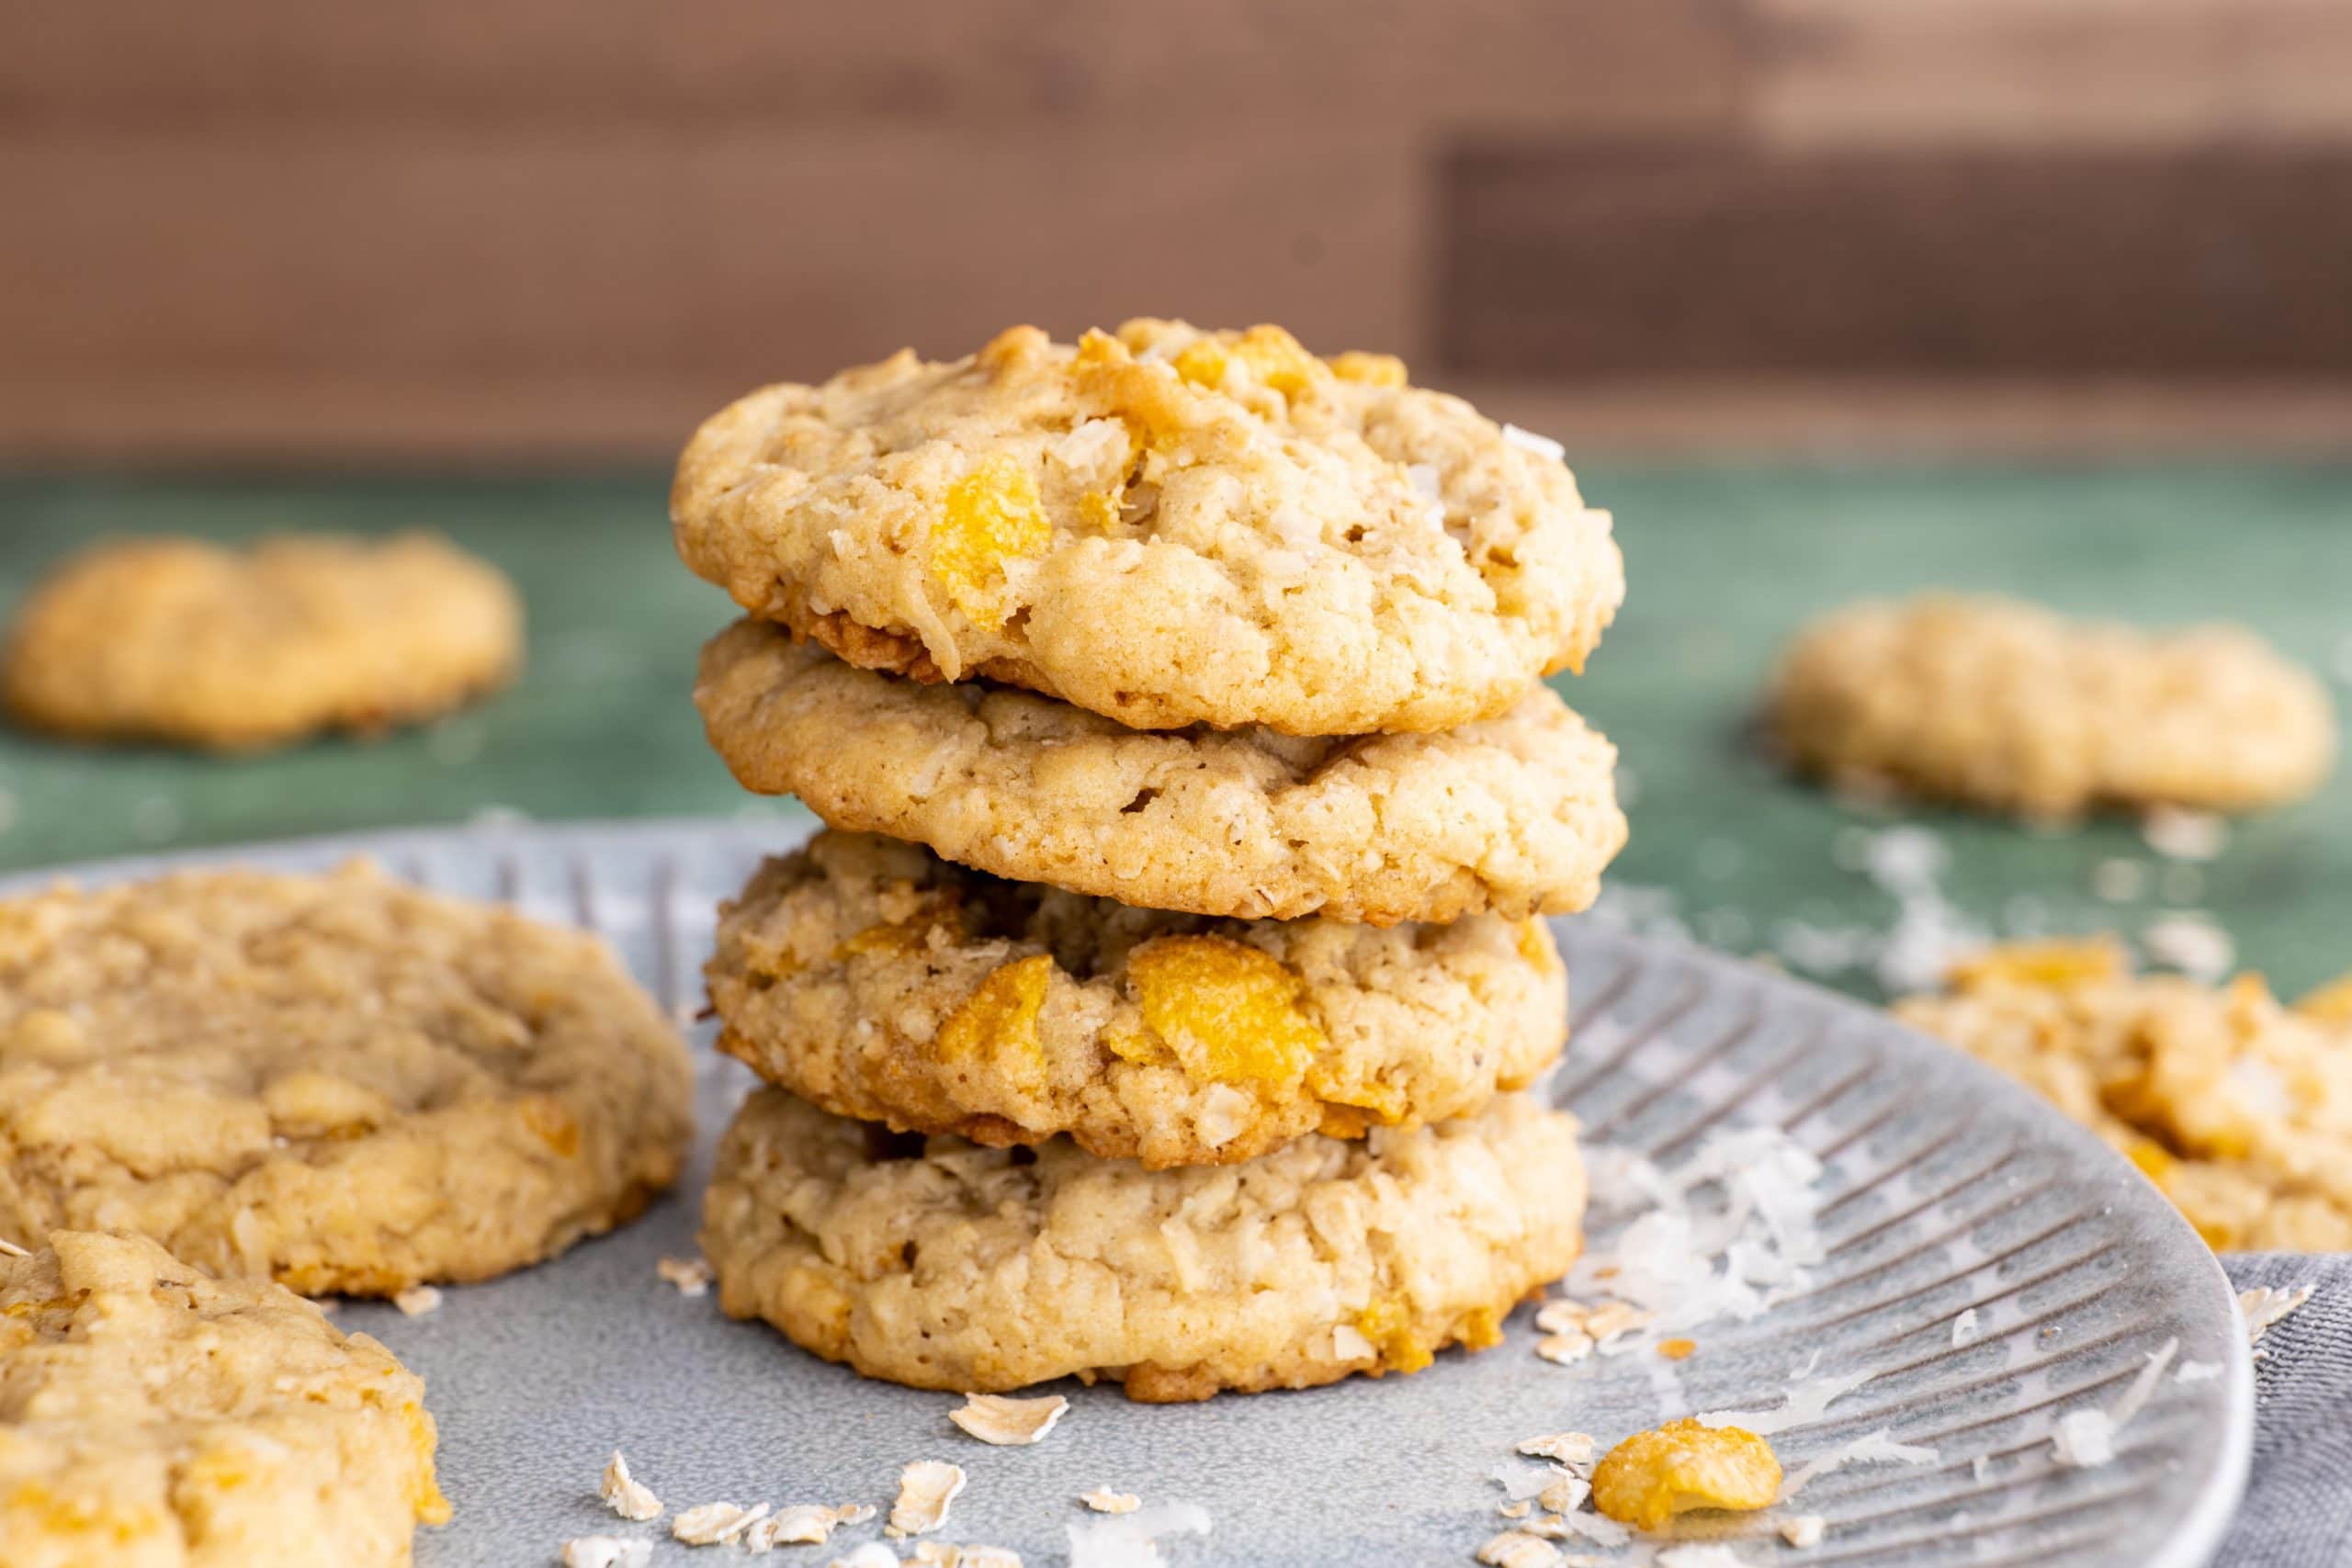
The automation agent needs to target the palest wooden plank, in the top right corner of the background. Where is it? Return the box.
[1750,0,2352,148]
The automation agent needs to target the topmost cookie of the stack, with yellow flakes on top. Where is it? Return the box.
[671,320,1625,736]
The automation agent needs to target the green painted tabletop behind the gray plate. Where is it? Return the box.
[0,466,2352,992]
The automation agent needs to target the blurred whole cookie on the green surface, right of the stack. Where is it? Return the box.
[1771,594,2335,818]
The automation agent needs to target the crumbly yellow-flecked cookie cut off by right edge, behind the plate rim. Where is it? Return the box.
[1895,942,2352,1253]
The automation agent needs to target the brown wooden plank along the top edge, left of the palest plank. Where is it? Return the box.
[0,0,1738,139]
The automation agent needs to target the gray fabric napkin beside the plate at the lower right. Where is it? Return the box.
[2213,1253,2352,1568]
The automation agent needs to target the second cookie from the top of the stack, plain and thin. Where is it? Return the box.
[694,621,1625,926]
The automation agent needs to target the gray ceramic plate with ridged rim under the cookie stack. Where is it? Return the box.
[18,823,2253,1568]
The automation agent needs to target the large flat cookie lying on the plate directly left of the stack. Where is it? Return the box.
[0,865,692,1295]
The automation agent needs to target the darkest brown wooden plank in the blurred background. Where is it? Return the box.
[1440,146,2352,378]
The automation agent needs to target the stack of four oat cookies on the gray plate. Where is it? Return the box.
[673,320,1625,1401]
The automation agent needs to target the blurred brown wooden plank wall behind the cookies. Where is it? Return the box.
[0,0,2352,463]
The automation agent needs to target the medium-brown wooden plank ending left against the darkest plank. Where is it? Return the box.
[0,130,1425,388]
